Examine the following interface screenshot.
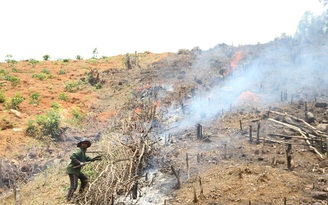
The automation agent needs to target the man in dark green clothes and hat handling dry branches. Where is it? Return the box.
[66,139,101,201]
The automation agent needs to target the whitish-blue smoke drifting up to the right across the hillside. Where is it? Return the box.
[161,39,328,132]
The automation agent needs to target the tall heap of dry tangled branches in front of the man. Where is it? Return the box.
[75,85,160,205]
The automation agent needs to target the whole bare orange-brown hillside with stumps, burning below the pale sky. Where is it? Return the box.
[0,38,328,204]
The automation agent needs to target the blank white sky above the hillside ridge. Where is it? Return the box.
[0,0,323,61]
